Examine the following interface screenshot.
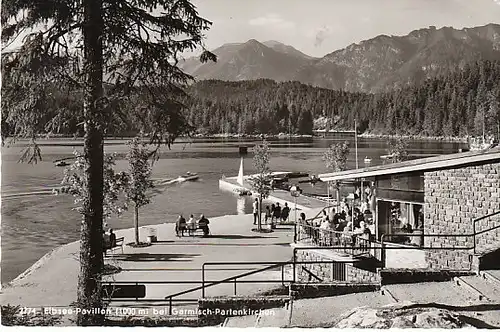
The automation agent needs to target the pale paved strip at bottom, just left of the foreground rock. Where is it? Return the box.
[290,291,392,327]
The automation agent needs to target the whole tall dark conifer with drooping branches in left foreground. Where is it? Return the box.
[1,0,215,325]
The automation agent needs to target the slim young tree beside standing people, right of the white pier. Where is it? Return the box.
[250,141,272,231]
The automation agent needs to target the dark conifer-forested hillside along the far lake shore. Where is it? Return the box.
[187,61,500,136]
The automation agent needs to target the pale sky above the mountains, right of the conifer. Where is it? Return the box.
[193,0,500,57]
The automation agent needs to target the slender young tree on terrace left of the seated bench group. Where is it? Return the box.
[125,137,153,244]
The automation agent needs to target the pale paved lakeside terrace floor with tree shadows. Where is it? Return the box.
[1,212,300,307]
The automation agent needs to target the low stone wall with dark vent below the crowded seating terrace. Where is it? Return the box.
[296,249,380,284]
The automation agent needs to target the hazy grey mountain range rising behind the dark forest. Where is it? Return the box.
[181,24,500,92]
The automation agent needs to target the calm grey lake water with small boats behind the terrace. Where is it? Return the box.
[1,137,466,283]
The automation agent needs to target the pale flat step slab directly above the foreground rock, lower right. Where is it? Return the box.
[383,281,477,305]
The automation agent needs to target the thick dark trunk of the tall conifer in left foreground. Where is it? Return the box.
[77,0,104,326]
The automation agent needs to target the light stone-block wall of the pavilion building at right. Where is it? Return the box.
[424,162,500,270]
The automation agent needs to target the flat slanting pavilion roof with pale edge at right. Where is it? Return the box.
[318,147,500,181]
